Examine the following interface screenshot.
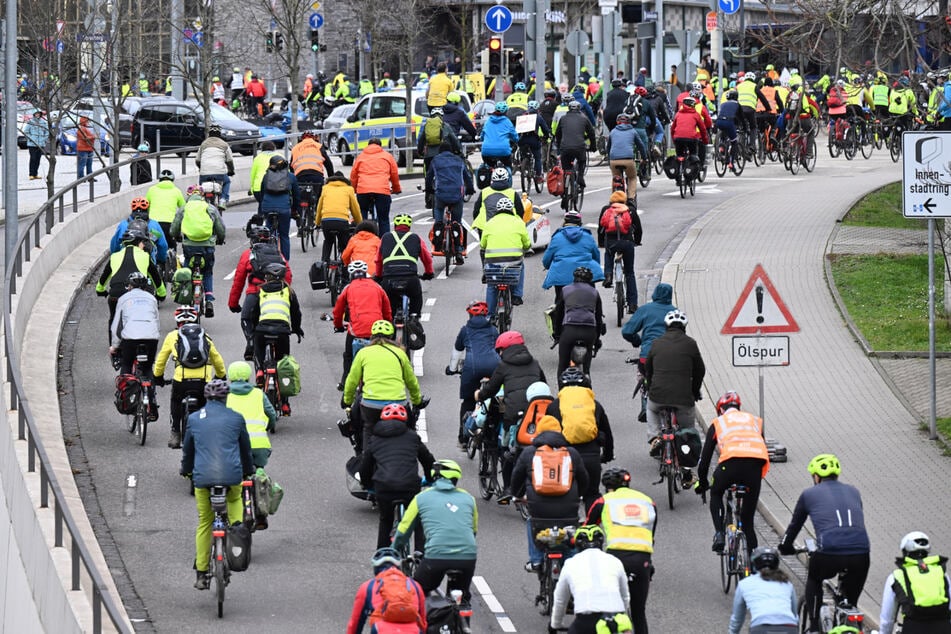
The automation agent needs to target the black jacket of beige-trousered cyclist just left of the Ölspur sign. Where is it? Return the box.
[645,326,706,407]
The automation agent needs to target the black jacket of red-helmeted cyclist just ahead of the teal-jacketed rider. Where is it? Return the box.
[360,420,434,493]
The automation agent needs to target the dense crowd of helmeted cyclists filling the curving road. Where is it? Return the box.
[83,55,951,634]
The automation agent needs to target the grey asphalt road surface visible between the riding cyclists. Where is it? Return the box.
[60,158,820,632]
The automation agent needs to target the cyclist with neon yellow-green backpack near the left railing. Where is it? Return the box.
[170,187,225,317]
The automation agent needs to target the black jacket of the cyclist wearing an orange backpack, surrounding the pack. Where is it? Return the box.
[512,431,588,519]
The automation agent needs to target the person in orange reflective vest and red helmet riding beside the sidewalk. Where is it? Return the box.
[696,391,769,553]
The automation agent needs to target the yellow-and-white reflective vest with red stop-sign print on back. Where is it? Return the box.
[601,487,657,553]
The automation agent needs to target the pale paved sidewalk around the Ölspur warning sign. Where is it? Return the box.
[664,163,951,622]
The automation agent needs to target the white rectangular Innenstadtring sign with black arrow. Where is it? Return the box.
[901,132,951,218]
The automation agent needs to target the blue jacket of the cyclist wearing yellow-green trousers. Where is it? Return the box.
[179,400,254,489]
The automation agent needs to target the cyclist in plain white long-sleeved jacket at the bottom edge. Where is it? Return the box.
[550,525,631,634]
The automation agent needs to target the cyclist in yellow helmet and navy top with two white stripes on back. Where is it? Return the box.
[778,453,870,631]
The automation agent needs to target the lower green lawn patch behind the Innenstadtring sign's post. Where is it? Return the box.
[831,254,951,352]
